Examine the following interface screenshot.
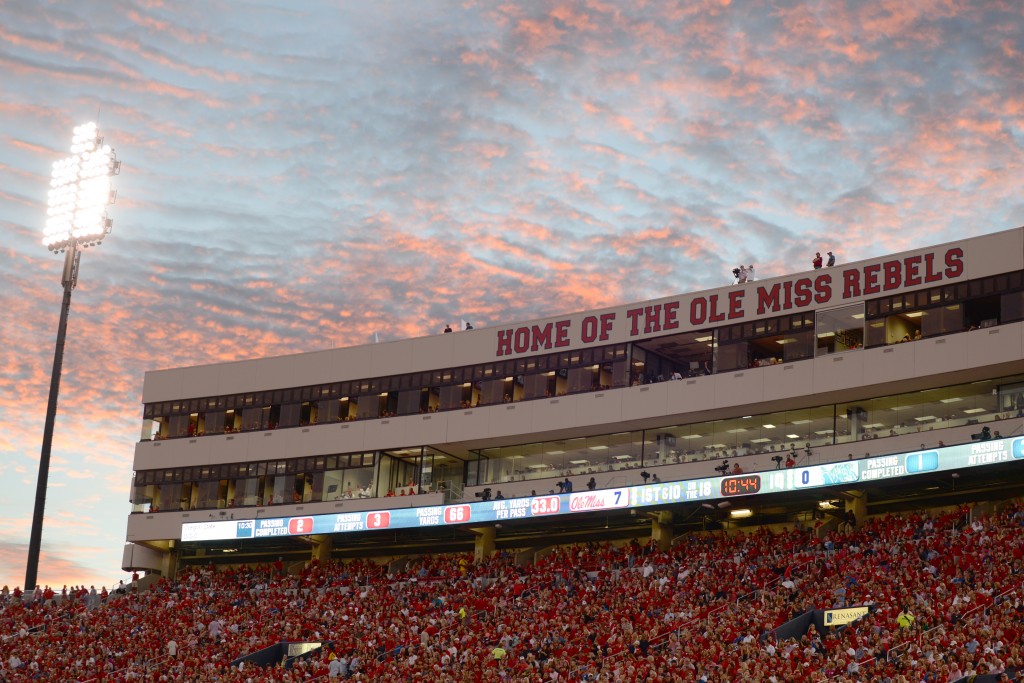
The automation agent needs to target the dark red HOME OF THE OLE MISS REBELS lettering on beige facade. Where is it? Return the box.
[495,247,965,356]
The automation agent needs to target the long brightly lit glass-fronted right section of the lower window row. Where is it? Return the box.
[476,375,1024,485]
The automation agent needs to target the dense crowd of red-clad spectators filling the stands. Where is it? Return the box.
[0,504,1024,683]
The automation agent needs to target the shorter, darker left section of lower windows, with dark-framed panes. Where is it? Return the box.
[131,449,464,512]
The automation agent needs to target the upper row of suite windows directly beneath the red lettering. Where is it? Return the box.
[141,271,1024,440]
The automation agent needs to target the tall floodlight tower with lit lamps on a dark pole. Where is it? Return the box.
[25,123,121,591]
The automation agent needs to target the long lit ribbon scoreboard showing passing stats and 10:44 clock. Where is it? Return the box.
[181,437,1024,542]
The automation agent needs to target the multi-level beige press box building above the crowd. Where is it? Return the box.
[123,228,1024,573]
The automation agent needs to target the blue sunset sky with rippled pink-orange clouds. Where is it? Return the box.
[0,0,1024,587]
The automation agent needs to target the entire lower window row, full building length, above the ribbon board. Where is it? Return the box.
[131,374,1024,512]
